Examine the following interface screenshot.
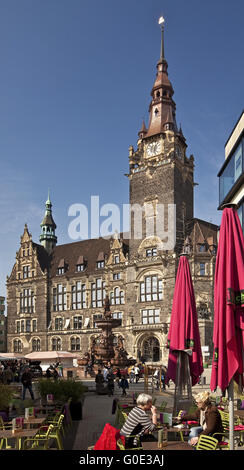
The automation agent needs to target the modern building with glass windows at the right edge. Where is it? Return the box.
[218,111,244,231]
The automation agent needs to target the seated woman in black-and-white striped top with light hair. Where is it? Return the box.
[120,393,157,447]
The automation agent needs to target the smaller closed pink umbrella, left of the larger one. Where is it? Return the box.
[167,256,203,385]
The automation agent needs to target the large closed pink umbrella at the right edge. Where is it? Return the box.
[210,207,244,392]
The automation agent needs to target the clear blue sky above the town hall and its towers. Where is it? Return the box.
[0,0,244,295]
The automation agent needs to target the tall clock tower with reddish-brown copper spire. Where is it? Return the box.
[128,18,194,259]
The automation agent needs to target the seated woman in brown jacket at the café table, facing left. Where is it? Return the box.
[181,392,223,445]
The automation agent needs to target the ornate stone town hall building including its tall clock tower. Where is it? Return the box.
[7,24,217,364]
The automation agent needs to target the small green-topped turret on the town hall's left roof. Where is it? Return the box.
[40,192,57,255]
